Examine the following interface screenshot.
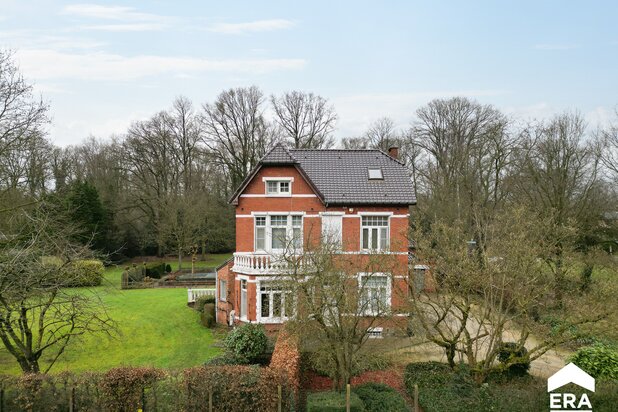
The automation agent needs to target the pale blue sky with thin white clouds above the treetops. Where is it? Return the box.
[0,0,618,145]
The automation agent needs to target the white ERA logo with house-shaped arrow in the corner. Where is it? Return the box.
[547,363,594,412]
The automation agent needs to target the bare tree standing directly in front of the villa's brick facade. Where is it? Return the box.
[274,232,404,389]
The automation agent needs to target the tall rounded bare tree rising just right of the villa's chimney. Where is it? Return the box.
[408,97,516,249]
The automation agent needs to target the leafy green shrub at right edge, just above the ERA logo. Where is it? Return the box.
[569,344,618,380]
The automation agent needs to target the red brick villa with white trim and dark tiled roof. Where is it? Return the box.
[216,145,416,327]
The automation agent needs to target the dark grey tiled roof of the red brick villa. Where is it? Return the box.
[230,144,416,205]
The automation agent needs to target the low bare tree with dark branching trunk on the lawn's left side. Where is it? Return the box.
[0,207,114,372]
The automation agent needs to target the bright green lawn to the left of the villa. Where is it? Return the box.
[0,254,230,374]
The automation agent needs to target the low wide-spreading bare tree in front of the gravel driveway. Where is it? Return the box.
[411,208,607,382]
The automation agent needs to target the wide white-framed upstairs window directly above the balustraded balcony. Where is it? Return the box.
[255,214,303,252]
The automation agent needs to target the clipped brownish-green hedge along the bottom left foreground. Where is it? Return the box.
[0,366,294,412]
